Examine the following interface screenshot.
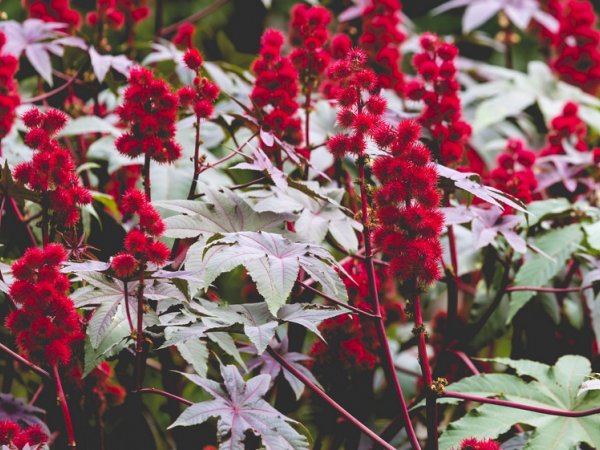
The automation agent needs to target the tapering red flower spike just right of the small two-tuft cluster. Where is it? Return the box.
[250,29,302,148]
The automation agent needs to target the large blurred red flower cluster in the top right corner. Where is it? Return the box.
[550,0,600,94]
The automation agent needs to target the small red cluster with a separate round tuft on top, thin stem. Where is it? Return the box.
[177,48,220,119]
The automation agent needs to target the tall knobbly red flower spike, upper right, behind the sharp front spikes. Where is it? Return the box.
[406,33,471,165]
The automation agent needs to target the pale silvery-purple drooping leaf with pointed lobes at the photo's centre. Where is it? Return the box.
[203,231,348,314]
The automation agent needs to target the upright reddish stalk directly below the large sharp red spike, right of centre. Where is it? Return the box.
[414,295,439,450]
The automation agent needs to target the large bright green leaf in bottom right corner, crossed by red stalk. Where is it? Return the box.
[440,355,600,450]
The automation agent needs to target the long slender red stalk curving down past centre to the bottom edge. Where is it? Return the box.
[359,159,421,450]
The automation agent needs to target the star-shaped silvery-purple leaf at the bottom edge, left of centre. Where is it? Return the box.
[169,366,309,450]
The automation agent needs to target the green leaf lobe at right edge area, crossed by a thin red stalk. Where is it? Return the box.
[507,224,583,322]
